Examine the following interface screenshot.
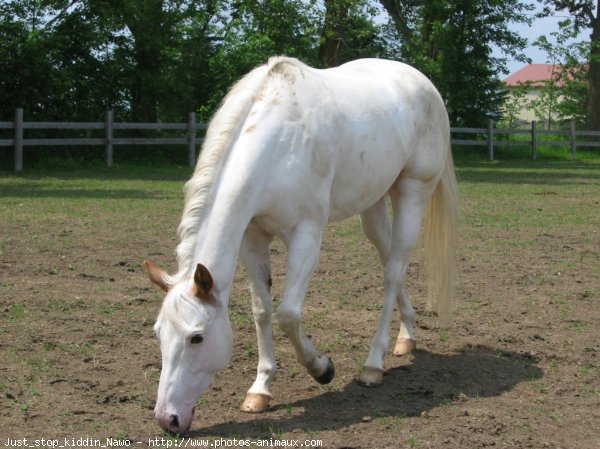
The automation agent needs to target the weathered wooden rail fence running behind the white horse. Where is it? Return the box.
[0,109,600,172]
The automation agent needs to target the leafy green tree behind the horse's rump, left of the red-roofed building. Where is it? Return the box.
[381,0,532,126]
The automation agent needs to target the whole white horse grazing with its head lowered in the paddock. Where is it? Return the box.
[145,58,457,432]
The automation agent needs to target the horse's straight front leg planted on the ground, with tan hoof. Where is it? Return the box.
[240,224,276,413]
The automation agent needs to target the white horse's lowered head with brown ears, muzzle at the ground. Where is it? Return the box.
[144,261,232,433]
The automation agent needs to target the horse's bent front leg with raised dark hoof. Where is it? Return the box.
[278,221,335,384]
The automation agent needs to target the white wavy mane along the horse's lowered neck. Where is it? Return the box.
[175,57,300,280]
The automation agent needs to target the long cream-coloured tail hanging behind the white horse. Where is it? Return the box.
[425,146,458,327]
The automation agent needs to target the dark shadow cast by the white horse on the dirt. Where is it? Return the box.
[191,346,543,438]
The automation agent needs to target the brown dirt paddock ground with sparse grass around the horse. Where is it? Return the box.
[0,163,600,449]
